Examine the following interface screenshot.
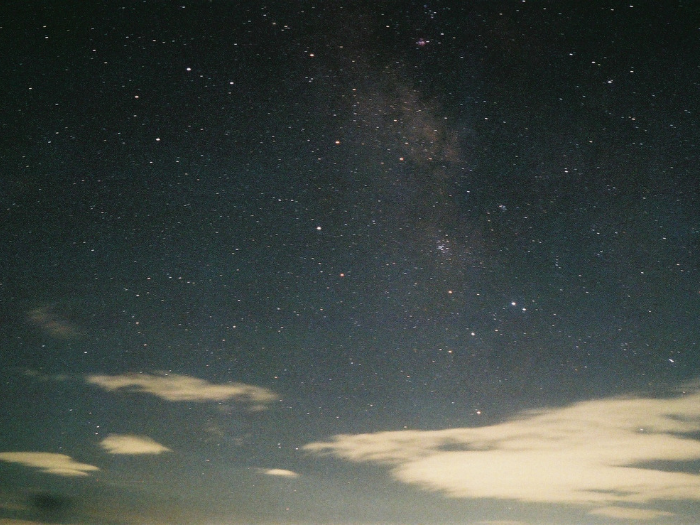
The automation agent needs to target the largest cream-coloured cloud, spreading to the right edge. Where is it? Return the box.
[304,390,700,519]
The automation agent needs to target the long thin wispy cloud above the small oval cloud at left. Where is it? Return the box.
[86,374,277,410]
